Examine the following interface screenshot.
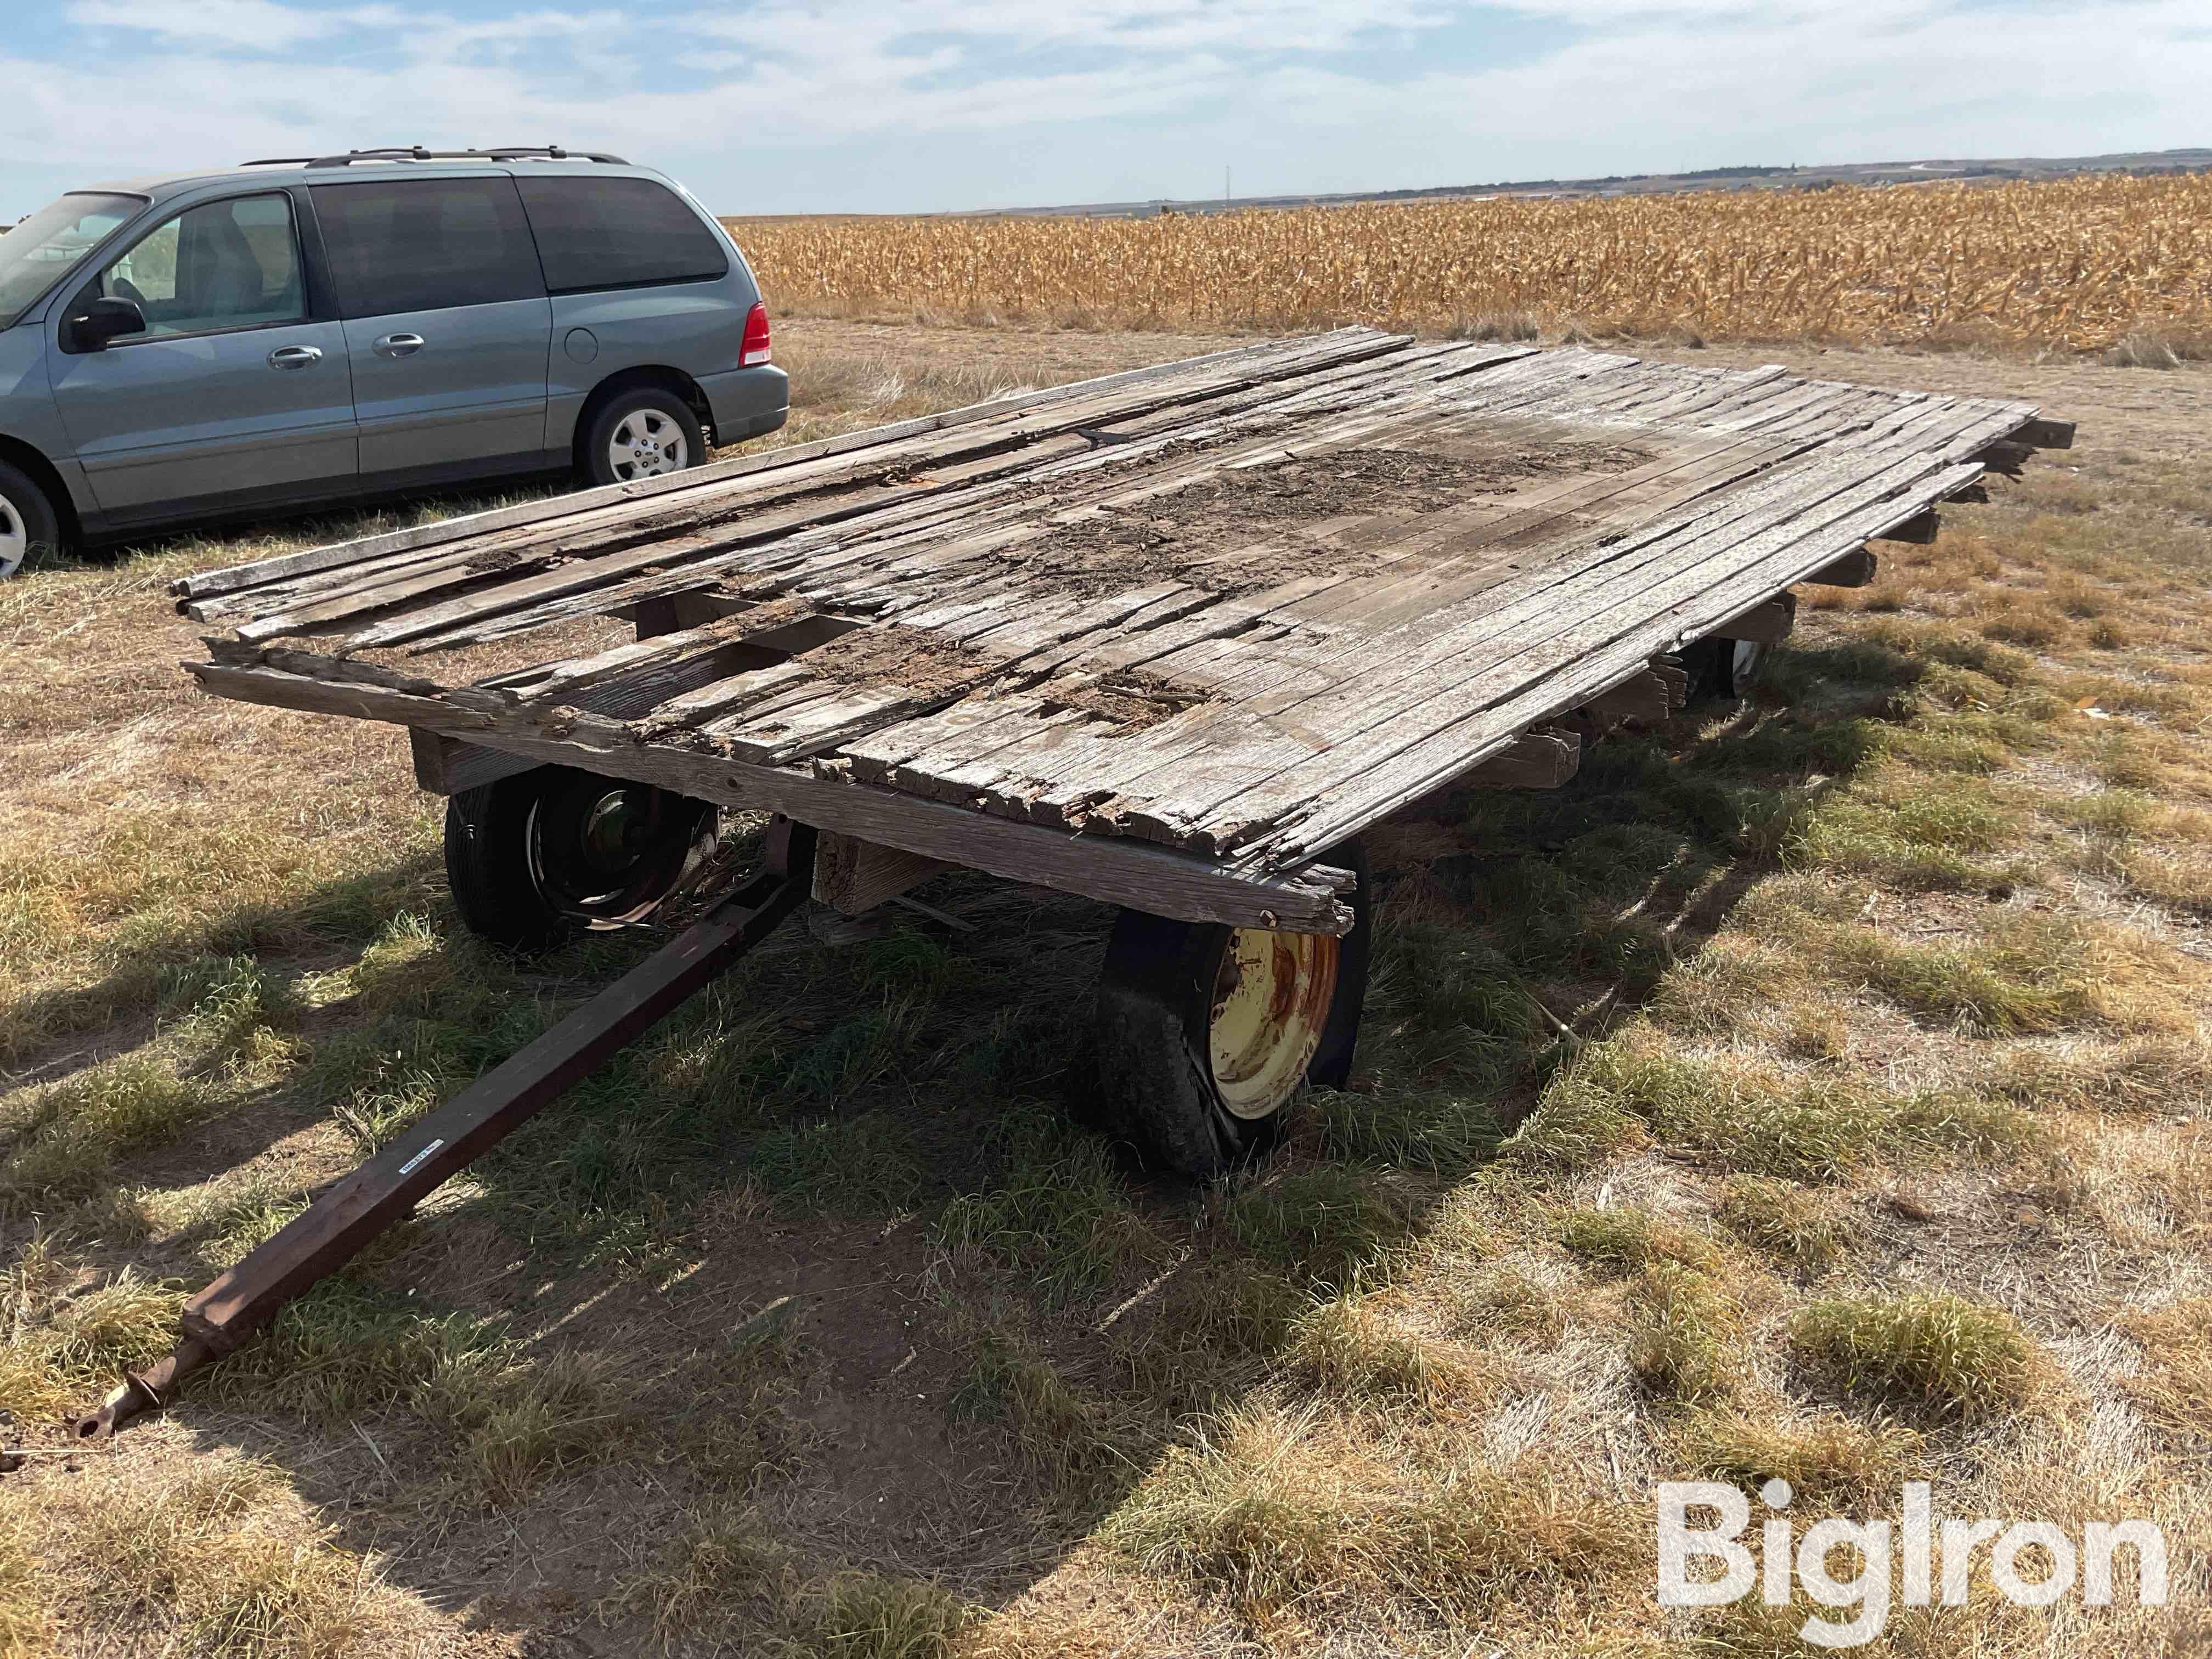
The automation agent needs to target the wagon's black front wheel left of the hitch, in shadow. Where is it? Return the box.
[444,765,714,951]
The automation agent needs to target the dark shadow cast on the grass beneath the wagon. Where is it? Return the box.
[39,646,1914,1654]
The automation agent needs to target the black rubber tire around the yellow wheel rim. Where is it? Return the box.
[1077,843,1372,1181]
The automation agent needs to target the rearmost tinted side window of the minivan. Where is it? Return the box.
[515,175,730,294]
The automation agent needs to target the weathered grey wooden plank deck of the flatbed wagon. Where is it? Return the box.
[177,330,2070,929]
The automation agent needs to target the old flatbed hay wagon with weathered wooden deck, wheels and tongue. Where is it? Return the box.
[77,330,2073,1436]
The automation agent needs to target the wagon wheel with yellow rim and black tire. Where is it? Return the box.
[1080,843,1369,1179]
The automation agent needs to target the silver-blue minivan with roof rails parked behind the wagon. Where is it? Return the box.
[0,148,789,575]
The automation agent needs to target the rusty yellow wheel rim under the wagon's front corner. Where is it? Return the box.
[1205,927,1338,1119]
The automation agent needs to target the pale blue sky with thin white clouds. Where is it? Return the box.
[0,0,2212,217]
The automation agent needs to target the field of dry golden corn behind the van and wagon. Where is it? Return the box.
[725,175,2212,349]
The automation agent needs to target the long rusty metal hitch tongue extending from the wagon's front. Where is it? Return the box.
[71,819,814,1440]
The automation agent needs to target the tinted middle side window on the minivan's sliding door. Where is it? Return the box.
[314,177,546,317]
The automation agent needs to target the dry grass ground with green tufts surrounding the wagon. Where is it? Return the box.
[0,323,2212,1659]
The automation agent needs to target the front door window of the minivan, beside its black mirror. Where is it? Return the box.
[99,193,307,341]
